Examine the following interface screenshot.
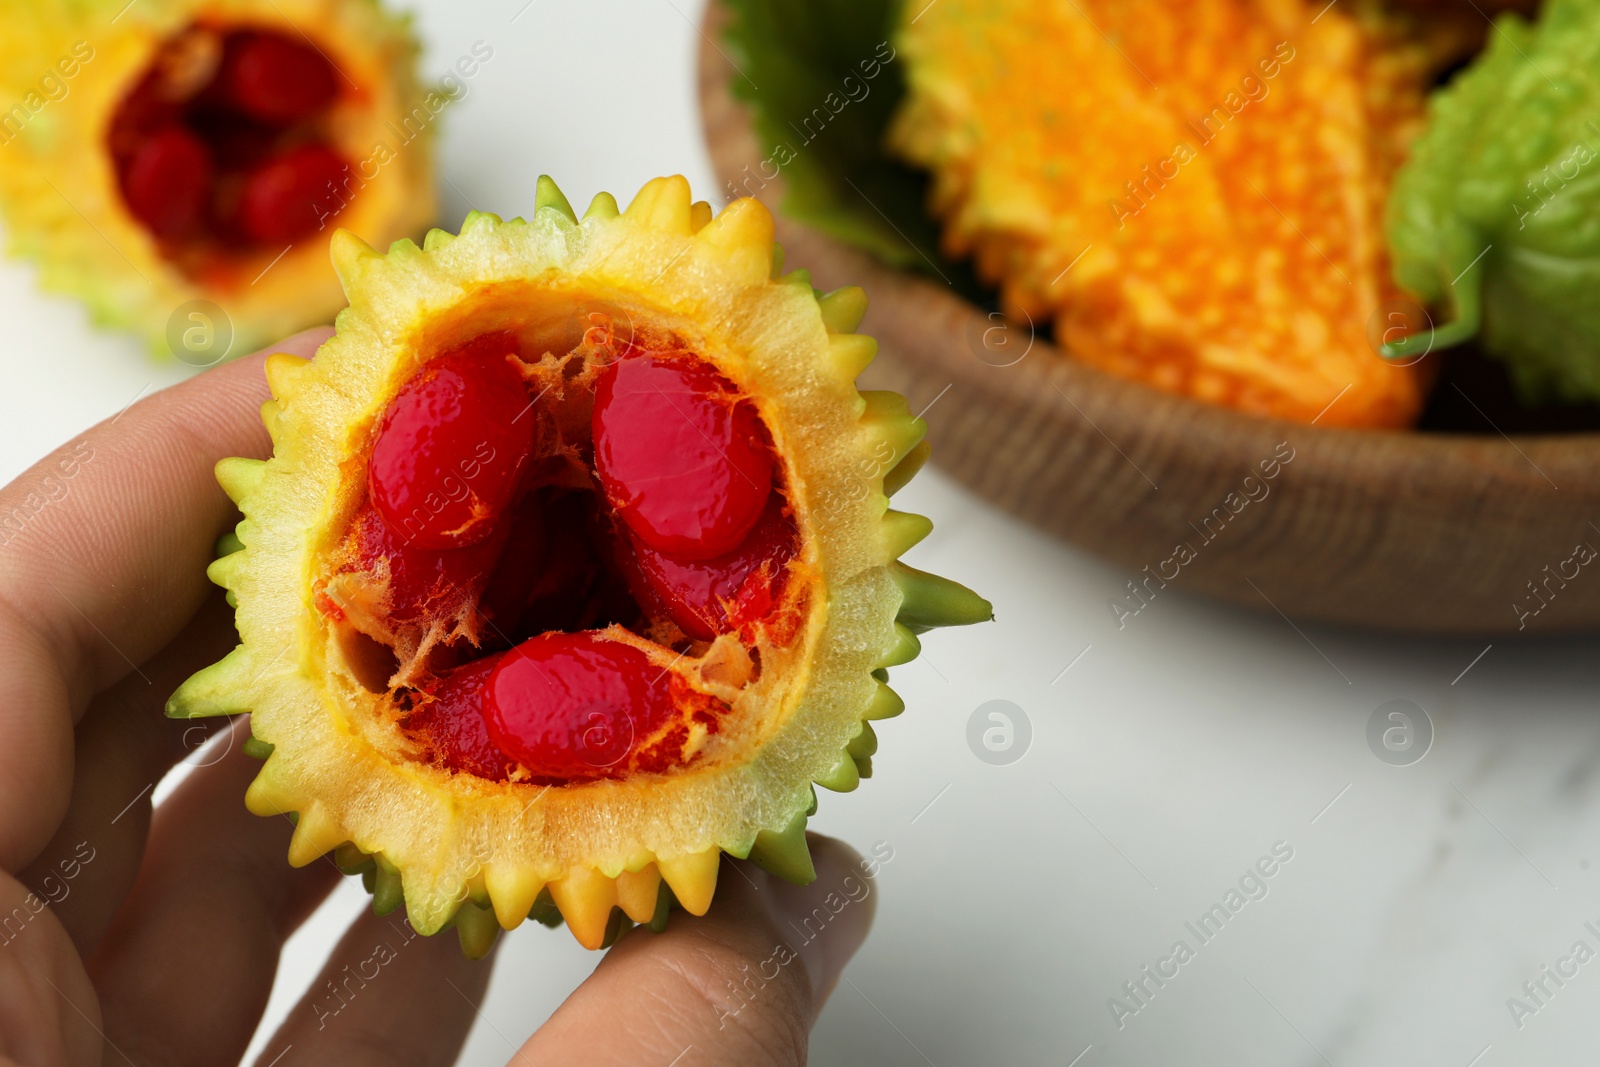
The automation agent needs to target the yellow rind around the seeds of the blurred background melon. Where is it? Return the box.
[0,0,443,355]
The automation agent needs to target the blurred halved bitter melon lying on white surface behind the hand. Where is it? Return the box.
[0,0,432,355]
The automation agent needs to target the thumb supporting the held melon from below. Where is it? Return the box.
[522,837,877,1067]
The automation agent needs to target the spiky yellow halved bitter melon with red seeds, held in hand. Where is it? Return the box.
[168,178,992,955]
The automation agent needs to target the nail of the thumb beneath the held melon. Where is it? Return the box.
[762,835,878,1011]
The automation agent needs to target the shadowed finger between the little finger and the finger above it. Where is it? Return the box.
[90,723,341,1067]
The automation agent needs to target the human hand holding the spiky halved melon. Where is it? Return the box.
[0,330,877,1067]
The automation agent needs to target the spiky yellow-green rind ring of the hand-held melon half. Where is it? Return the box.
[168,178,992,955]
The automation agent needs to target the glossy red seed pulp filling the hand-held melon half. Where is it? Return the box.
[328,333,798,784]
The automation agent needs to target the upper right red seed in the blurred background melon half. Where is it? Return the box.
[216,34,339,126]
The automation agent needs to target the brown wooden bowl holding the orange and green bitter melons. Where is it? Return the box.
[699,8,1600,633]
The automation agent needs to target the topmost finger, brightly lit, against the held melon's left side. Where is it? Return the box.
[0,330,328,704]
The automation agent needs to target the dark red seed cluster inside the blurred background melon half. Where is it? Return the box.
[107,26,349,259]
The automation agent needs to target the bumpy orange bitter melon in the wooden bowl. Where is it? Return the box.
[890,0,1482,427]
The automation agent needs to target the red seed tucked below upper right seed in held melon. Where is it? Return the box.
[632,493,798,641]
